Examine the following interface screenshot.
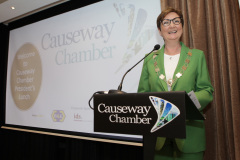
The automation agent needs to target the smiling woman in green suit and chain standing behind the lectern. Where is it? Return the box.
[138,8,213,160]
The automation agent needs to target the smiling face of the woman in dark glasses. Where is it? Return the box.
[158,12,183,42]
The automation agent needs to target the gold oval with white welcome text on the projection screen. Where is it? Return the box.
[11,43,42,110]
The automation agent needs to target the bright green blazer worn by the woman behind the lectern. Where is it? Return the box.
[138,42,214,153]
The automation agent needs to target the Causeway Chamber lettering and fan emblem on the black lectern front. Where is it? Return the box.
[97,96,180,133]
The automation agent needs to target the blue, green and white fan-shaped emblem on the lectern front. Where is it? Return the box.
[149,96,180,132]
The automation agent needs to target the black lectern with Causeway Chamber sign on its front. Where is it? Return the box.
[93,91,204,160]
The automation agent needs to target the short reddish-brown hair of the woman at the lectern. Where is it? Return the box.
[157,7,184,30]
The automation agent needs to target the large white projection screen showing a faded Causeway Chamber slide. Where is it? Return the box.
[5,0,163,142]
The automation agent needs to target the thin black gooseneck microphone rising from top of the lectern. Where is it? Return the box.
[108,44,160,94]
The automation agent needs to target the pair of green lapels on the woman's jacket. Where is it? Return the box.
[155,42,189,91]
